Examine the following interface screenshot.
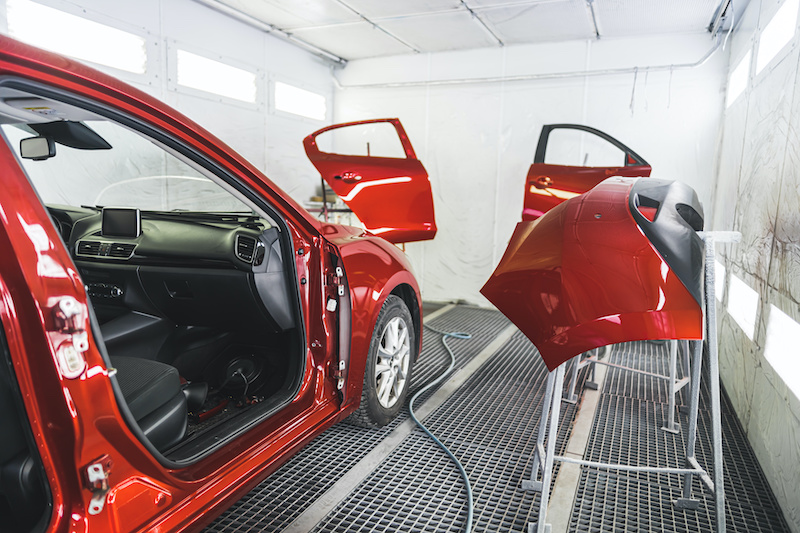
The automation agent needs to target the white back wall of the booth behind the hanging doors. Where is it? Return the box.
[334,34,727,305]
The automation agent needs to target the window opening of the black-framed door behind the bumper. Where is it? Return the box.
[544,128,625,167]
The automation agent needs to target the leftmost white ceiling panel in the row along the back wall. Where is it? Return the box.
[292,22,413,59]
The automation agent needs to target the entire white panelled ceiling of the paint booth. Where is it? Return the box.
[198,0,727,61]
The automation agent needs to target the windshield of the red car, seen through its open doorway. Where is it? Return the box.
[2,120,252,213]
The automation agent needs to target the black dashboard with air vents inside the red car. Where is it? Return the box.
[48,206,295,339]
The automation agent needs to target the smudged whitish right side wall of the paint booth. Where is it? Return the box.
[713,0,800,532]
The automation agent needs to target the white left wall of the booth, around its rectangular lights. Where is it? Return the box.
[0,0,333,205]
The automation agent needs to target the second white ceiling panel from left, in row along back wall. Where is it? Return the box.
[381,11,497,52]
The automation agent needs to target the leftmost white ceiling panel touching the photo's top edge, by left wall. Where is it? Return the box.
[218,0,361,30]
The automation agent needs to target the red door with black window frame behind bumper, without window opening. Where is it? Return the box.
[522,124,652,221]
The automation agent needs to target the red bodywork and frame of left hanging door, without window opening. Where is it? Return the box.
[303,118,436,243]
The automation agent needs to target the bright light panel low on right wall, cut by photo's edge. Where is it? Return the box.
[764,305,800,398]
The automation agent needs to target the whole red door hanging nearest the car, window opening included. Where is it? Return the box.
[303,118,436,243]
